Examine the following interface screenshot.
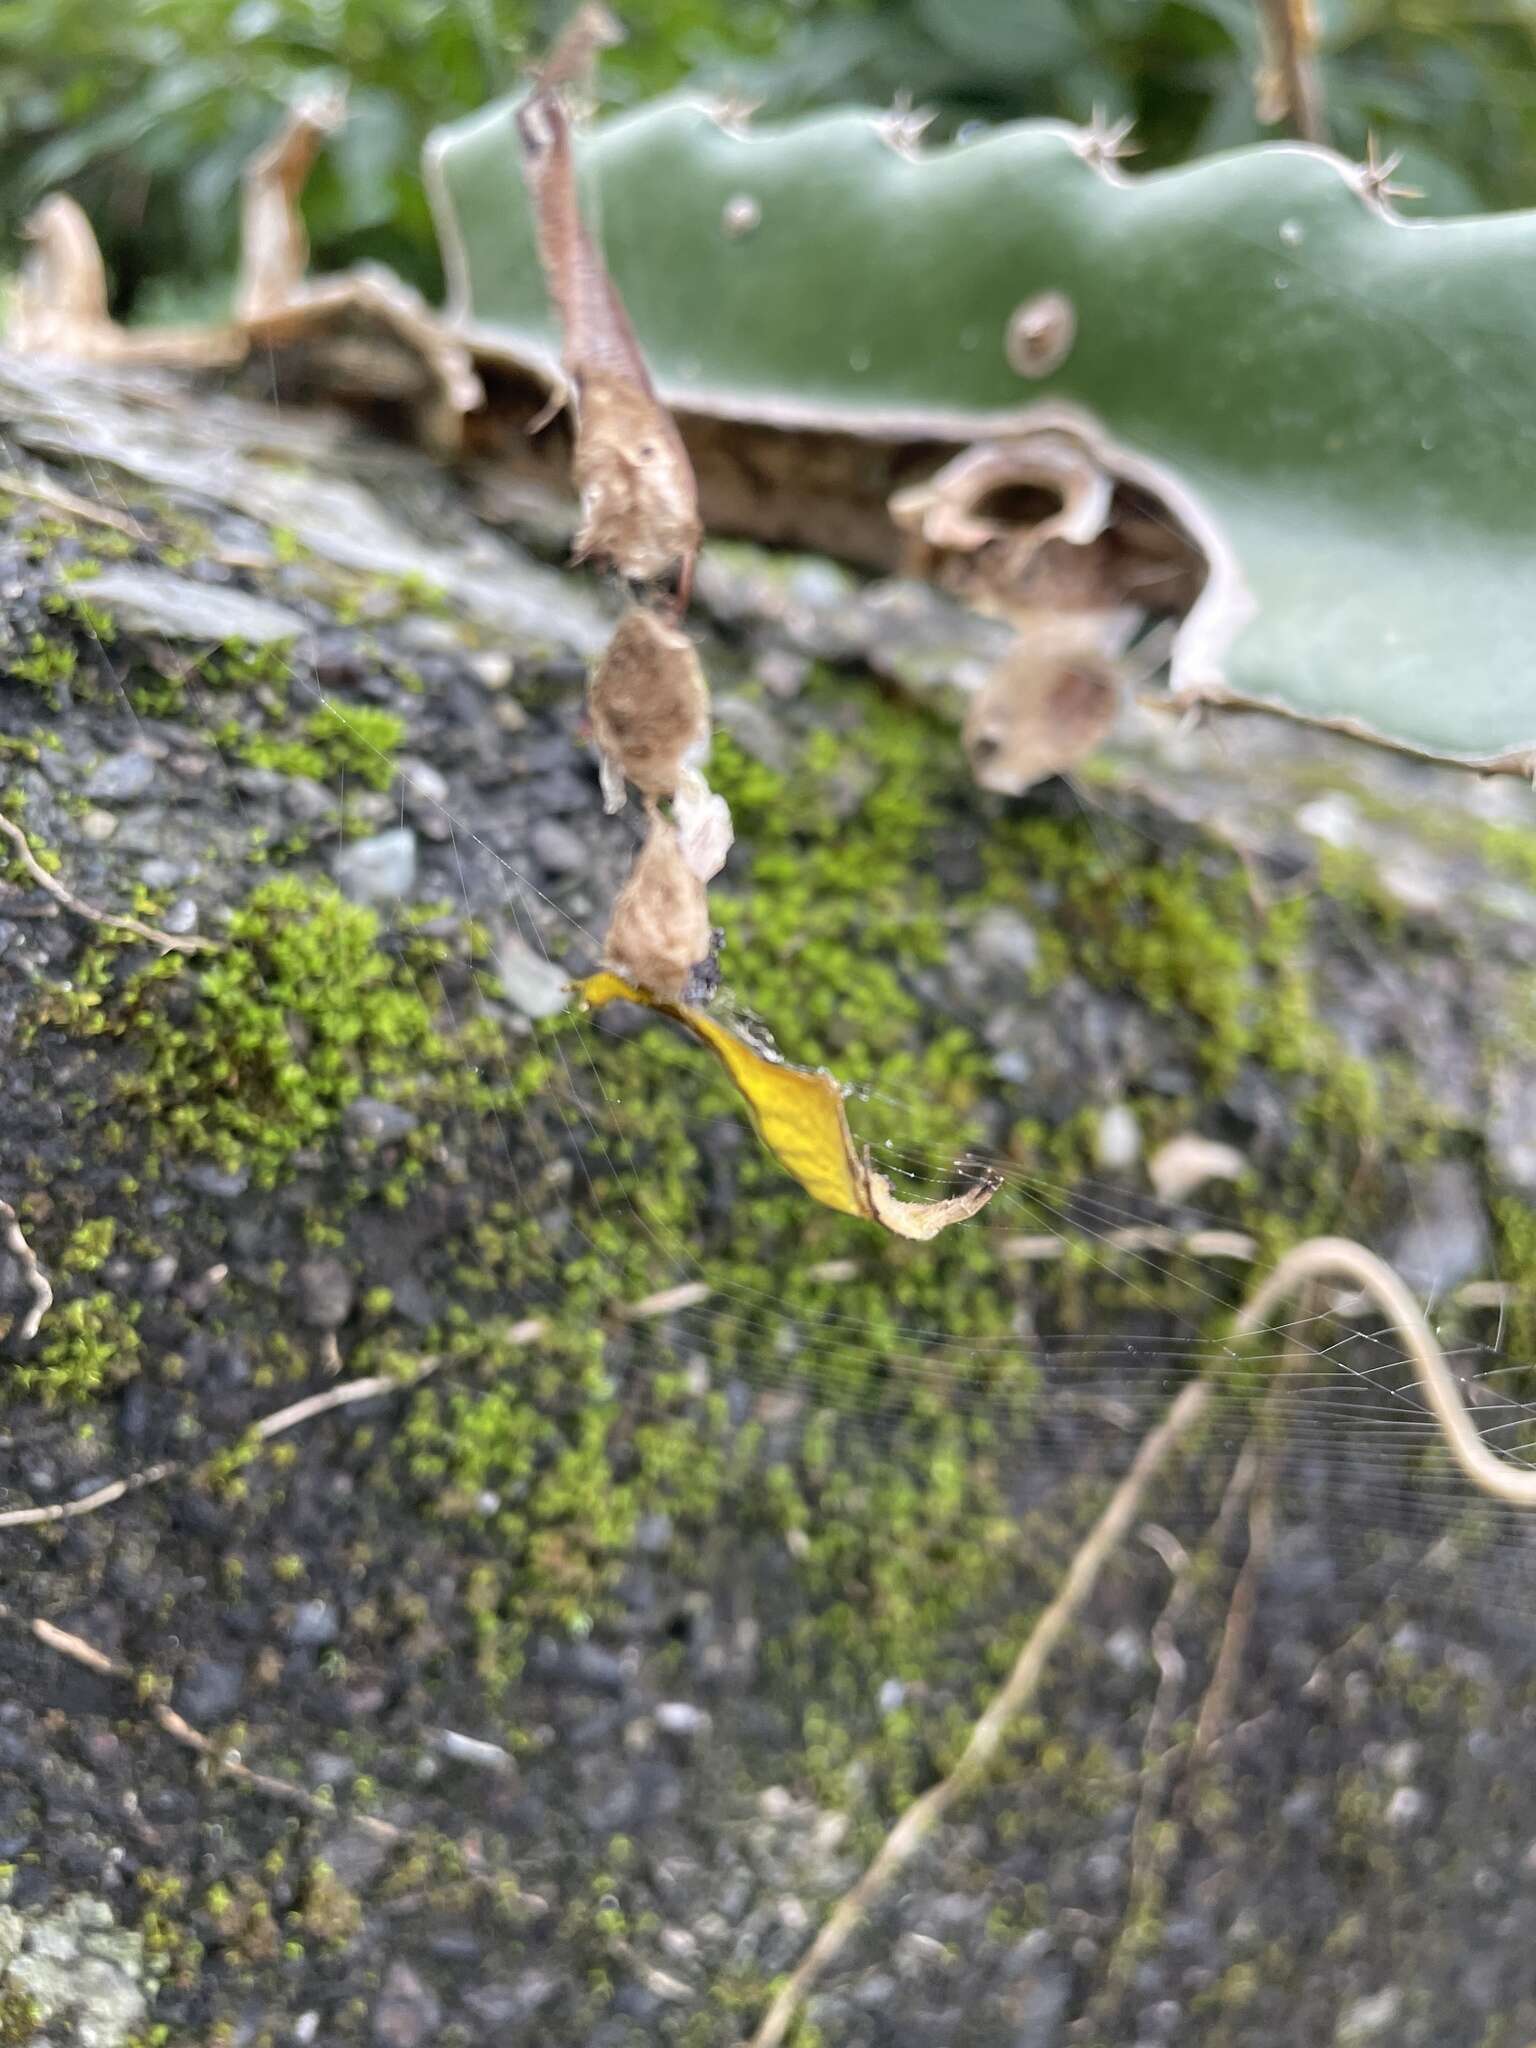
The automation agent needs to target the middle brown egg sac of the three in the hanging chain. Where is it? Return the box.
[586,604,709,811]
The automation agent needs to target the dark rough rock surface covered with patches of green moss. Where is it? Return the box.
[0,358,1536,2048]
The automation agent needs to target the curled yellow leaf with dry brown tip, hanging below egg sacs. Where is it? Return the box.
[575,973,997,1239]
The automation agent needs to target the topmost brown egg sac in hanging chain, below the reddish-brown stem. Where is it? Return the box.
[571,362,702,584]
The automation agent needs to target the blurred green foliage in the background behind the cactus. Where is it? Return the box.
[0,0,1536,317]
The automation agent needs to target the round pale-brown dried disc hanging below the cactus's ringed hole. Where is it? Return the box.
[965,616,1120,797]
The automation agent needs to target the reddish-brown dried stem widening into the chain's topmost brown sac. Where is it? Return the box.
[518,86,700,606]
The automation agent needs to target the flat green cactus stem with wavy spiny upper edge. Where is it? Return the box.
[428,100,1536,772]
